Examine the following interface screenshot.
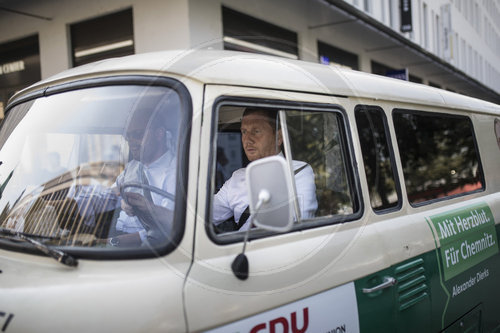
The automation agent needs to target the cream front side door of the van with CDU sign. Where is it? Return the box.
[185,85,394,333]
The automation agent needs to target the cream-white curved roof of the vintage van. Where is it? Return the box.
[10,50,500,114]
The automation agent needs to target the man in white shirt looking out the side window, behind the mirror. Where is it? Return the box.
[212,108,318,231]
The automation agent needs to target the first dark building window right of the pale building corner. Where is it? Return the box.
[222,6,299,59]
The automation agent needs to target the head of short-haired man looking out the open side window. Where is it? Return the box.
[241,113,282,161]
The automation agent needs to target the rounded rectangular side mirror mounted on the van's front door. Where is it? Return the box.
[246,156,294,232]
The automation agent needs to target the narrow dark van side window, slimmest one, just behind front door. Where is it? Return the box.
[354,105,401,212]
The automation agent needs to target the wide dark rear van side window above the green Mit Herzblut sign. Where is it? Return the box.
[393,109,484,205]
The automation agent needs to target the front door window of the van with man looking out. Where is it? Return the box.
[210,105,360,233]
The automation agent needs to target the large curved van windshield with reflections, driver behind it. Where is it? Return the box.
[0,85,182,254]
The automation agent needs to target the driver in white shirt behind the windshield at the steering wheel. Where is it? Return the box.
[109,107,176,246]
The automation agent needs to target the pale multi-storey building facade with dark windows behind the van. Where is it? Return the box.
[0,0,500,116]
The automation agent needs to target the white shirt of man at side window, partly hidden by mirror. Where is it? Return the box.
[212,154,318,230]
